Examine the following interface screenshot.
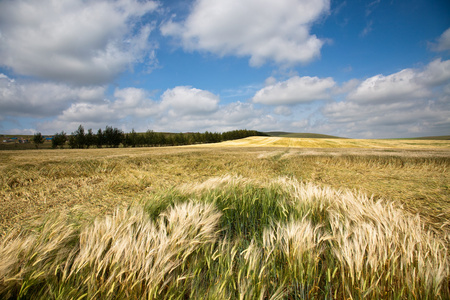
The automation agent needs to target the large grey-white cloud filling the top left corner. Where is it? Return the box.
[0,0,158,85]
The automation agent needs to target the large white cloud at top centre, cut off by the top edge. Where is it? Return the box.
[161,0,330,66]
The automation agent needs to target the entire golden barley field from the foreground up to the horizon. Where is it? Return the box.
[0,137,450,299]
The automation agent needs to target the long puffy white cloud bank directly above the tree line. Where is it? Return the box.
[44,86,277,133]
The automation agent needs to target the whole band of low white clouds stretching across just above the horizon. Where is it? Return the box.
[4,59,450,138]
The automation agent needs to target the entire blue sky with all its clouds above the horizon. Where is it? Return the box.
[0,0,450,138]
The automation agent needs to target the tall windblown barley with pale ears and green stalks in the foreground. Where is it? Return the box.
[0,175,450,299]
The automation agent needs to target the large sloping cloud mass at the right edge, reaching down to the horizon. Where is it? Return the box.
[321,59,450,138]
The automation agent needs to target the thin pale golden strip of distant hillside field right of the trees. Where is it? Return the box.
[209,136,450,149]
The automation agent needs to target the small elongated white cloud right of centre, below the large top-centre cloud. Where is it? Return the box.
[252,76,335,105]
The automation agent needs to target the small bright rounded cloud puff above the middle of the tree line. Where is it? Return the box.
[161,86,219,117]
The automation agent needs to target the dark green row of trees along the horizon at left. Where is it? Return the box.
[33,125,266,149]
